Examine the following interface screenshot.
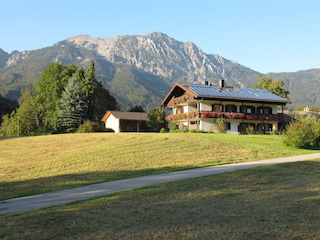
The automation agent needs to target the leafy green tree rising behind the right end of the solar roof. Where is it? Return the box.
[253,77,289,98]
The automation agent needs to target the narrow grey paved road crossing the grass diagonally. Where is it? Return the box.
[0,153,320,215]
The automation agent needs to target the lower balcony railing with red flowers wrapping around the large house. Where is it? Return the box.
[166,111,284,121]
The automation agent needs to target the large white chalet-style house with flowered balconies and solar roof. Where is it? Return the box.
[161,80,289,133]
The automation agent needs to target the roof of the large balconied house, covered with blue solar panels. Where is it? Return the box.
[161,83,289,106]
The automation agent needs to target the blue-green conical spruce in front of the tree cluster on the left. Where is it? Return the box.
[58,75,88,132]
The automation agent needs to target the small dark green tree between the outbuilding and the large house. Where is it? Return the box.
[147,108,167,132]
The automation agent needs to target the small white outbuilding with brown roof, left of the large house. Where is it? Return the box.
[101,111,147,133]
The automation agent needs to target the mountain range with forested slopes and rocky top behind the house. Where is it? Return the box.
[0,32,320,110]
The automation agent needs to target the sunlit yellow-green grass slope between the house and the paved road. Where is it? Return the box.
[0,133,313,200]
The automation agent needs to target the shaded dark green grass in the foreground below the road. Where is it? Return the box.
[0,159,320,240]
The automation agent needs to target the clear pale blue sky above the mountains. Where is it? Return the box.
[0,0,320,73]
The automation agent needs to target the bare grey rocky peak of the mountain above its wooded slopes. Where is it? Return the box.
[68,32,255,82]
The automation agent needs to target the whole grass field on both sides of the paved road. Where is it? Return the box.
[0,133,320,240]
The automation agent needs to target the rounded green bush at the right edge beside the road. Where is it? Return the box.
[284,116,320,148]
